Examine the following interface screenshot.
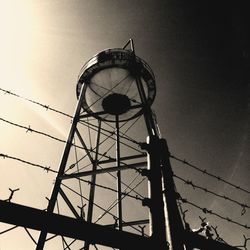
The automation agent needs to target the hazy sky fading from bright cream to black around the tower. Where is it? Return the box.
[0,0,250,249]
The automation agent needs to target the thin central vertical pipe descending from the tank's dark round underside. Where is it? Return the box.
[115,115,122,231]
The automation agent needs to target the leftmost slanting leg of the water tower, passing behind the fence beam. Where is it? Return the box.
[36,84,84,250]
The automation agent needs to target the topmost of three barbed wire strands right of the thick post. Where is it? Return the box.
[169,154,250,194]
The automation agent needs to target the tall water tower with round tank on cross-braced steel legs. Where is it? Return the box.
[33,40,182,249]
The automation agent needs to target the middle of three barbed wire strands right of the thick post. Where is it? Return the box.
[173,174,250,215]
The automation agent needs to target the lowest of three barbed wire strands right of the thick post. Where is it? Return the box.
[177,193,250,229]
